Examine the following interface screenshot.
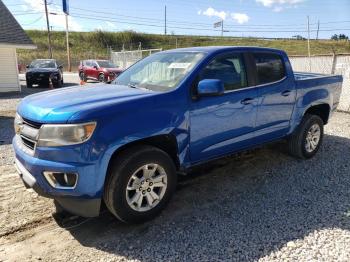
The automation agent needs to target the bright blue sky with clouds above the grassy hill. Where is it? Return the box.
[0,0,350,39]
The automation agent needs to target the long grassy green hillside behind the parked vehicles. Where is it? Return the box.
[18,30,350,70]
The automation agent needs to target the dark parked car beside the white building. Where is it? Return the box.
[26,59,63,88]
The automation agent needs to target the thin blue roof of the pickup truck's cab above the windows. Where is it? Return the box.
[165,46,284,54]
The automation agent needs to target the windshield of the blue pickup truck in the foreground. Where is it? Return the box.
[113,52,204,92]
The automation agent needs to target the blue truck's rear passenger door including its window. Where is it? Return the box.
[253,53,296,143]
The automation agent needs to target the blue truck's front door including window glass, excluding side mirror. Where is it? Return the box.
[190,53,258,162]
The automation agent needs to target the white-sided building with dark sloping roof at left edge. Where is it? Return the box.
[0,0,36,93]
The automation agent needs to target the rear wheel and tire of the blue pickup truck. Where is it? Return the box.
[288,114,323,159]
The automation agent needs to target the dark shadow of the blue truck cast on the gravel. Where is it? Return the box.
[45,135,350,261]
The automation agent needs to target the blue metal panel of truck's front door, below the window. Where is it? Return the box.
[190,88,257,161]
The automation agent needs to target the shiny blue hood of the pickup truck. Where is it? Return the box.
[17,84,156,123]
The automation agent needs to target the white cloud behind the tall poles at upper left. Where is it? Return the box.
[24,0,82,31]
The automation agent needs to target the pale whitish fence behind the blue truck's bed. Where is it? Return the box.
[289,54,350,112]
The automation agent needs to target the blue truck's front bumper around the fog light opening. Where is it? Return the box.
[13,138,101,217]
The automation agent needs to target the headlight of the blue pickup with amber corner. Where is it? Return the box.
[37,122,96,146]
